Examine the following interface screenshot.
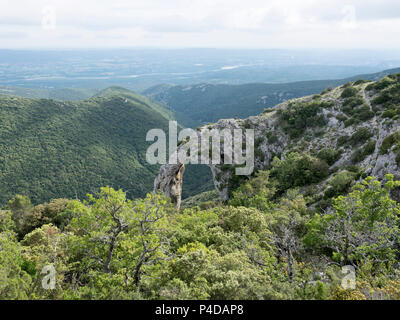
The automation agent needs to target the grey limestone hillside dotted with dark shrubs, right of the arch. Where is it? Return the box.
[156,74,400,206]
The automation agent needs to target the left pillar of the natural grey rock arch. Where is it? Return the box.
[154,163,185,209]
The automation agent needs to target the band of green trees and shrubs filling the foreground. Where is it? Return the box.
[0,171,400,300]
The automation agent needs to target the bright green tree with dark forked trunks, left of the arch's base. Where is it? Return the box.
[70,187,173,298]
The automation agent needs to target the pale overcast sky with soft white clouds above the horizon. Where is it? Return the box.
[0,0,400,49]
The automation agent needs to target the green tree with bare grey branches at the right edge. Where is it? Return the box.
[305,175,400,266]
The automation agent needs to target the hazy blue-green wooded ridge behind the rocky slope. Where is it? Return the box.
[143,68,400,127]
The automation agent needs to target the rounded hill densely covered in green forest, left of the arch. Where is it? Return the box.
[0,88,175,204]
